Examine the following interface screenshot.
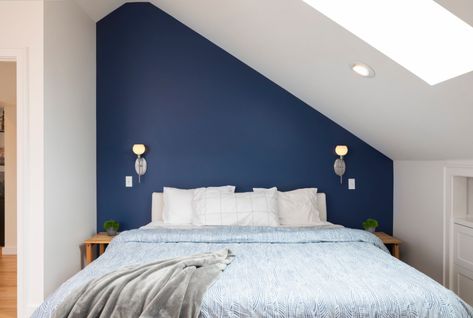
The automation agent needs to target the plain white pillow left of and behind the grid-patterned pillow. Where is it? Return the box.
[163,186,235,225]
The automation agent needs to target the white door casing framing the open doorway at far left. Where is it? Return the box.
[0,49,31,317]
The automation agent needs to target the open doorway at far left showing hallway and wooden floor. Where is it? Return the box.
[0,61,17,317]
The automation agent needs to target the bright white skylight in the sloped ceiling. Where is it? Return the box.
[303,0,473,85]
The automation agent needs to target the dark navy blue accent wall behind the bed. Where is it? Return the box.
[97,3,393,232]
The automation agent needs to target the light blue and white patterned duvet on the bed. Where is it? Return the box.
[33,227,473,318]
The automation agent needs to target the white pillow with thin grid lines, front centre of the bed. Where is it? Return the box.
[193,189,279,226]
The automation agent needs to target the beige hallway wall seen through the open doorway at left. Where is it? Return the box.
[0,62,17,254]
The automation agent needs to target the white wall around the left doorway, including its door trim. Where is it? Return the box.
[0,0,44,318]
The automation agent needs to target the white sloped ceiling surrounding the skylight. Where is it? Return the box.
[76,0,473,160]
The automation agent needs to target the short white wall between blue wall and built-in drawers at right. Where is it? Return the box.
[394,161,445,283]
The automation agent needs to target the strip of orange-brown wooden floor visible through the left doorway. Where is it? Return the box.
[0,255,16,318]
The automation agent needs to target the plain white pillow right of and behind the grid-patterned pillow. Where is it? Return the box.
[253,188,321,226]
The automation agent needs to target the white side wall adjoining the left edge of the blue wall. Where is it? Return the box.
[44,0,96,295]
